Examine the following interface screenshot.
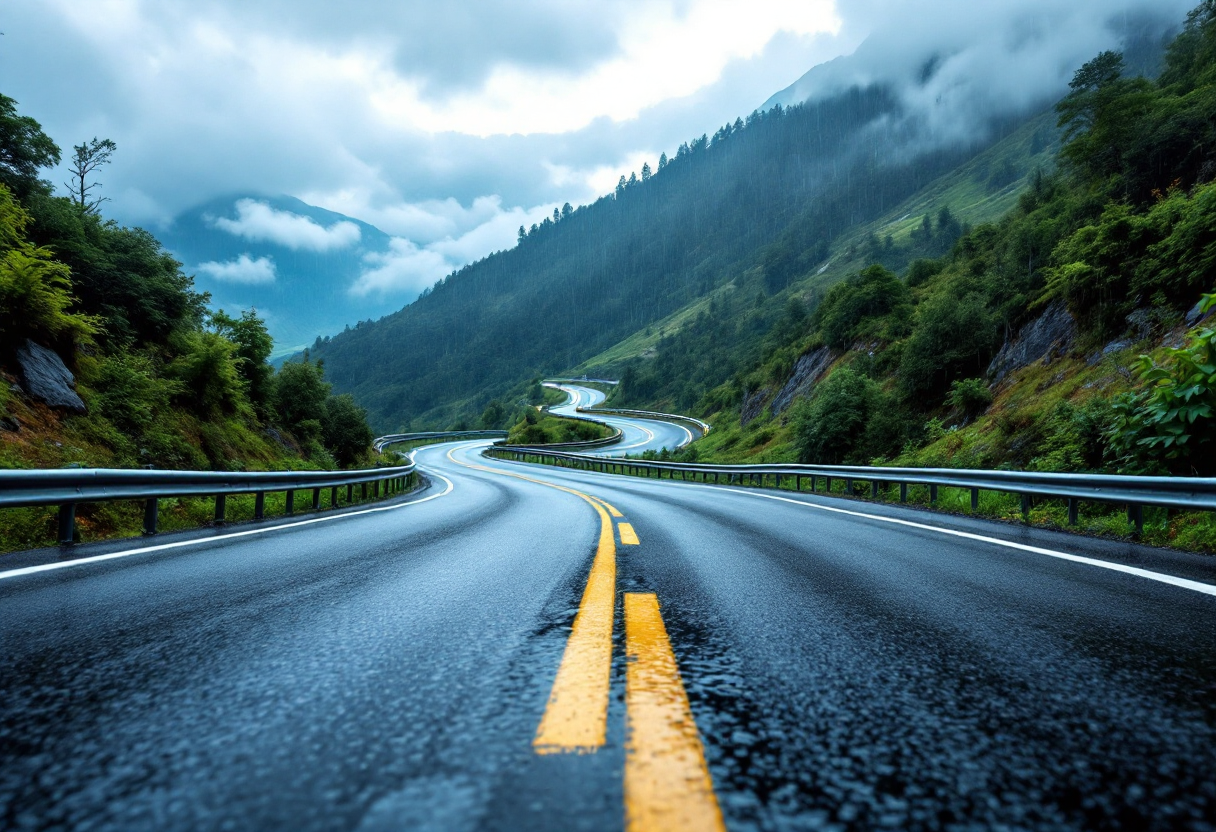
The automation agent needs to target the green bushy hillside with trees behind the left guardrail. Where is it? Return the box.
[0,96,371,470]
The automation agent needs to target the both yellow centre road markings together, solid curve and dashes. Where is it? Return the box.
[447,449,726,832]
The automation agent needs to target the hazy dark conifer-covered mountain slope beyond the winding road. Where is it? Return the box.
[314,79,1036,429]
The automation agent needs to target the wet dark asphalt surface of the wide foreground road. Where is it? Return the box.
[0,394,1216,830]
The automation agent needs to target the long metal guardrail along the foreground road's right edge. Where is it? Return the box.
[488,446,1216,532]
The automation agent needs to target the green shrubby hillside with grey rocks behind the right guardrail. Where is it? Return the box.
[632,1,1216,491]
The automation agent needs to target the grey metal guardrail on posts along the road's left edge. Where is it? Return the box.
[0,462,415,545]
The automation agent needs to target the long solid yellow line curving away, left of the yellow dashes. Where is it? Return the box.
[447,448,617,754]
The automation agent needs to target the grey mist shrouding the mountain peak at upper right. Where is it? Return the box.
[761,0,1193,151]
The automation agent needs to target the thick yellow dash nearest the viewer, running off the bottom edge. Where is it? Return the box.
[625,592,726,832]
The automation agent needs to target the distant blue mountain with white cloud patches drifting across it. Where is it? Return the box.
[161,195,401,355]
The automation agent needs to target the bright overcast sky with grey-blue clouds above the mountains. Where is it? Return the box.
[0,0,1192,300]
